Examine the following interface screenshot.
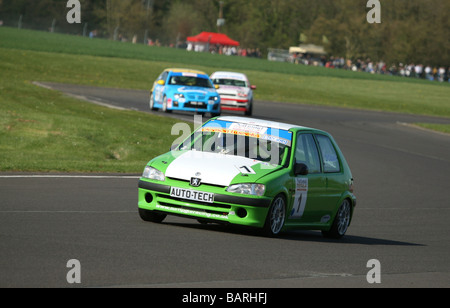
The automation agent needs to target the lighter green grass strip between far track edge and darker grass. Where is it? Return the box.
[0,44,450,117]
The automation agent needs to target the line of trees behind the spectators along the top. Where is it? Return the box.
[0,0,450,66]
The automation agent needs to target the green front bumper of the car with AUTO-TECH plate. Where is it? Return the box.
[138,179,271,228]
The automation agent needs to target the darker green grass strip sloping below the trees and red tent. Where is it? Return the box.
[0,27,428,83]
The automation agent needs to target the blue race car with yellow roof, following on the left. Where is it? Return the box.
[150,69,220,117]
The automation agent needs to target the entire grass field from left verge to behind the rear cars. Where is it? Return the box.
[0,27,450,173]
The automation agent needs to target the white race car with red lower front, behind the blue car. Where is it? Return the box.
[210,72,256,116]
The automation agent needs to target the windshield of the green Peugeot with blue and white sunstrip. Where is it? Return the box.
[181,120,292,165]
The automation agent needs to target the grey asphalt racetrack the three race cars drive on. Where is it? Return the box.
[0,84,450,288]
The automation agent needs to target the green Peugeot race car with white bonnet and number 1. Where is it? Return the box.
[138,117,356,238]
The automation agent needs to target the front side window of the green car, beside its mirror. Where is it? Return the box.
[295,134,320,173]
